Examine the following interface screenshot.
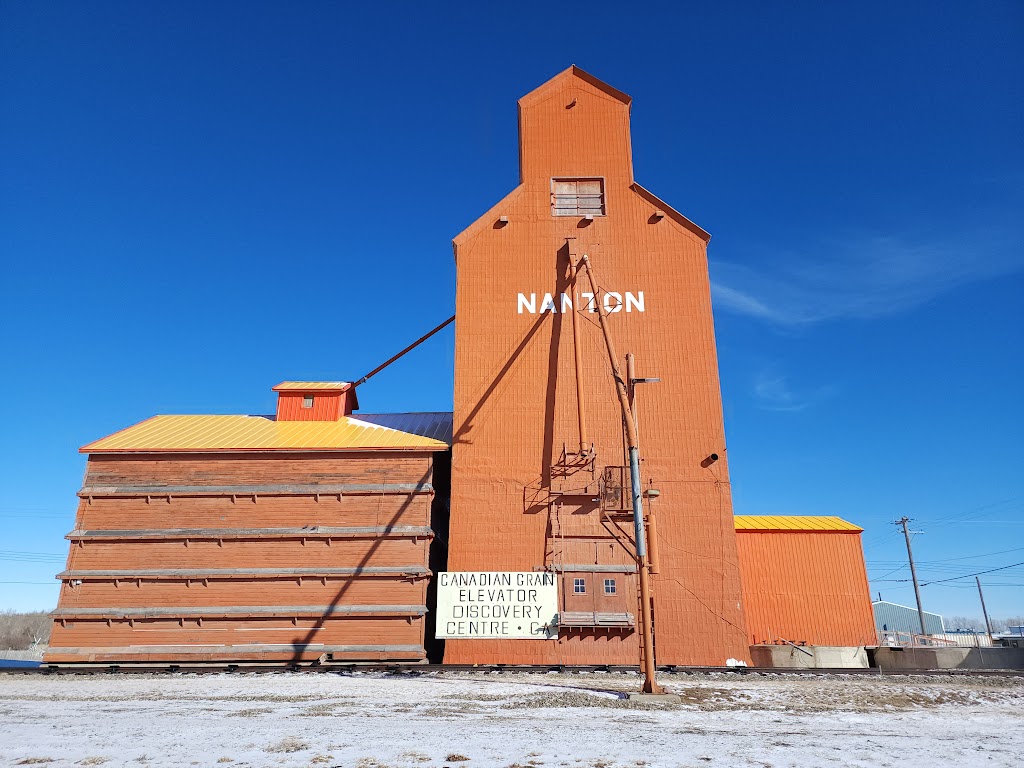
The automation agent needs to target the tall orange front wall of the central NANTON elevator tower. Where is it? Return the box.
[445,69,749,665]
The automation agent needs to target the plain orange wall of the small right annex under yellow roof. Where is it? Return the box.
[736,531,877,646]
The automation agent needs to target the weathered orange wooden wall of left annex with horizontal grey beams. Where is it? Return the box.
[46,453,433,664]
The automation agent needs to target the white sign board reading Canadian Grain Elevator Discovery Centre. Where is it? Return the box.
[434,570,558,640]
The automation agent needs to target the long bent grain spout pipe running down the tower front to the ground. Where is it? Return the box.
[580,254,665,693]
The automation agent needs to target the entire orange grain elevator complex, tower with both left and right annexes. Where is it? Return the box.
[44,67,876,667]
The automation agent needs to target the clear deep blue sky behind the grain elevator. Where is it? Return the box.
[0,1,1024,616]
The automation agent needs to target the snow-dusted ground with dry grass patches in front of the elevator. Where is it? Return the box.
[0,672,1024,768]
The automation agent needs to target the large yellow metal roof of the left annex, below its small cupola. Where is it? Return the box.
[86,413,452,454]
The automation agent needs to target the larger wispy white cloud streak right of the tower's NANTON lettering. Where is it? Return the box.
[712,228,1024,326]
